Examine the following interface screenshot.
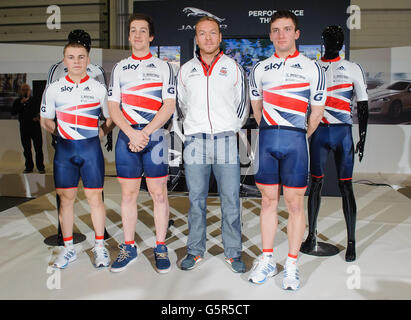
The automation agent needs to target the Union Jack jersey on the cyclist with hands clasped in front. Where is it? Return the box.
[108,53,176,125]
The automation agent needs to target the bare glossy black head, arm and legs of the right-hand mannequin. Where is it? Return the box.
[301,26,368,262]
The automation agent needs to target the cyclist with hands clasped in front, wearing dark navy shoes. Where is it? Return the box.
[108,14,176,273]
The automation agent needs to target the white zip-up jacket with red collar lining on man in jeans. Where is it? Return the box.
[177,51,249,135]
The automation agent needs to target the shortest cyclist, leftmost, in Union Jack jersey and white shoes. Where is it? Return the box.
[40,42,113,268]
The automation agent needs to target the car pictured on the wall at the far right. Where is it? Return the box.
[368,80,411,119]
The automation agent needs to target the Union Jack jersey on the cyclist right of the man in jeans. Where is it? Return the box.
[250,51,326,131]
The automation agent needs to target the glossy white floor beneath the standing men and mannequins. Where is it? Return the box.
[0,178,411,300]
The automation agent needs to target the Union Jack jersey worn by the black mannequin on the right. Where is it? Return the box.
[318,57,368,125]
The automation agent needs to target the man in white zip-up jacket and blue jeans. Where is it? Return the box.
[177,17,249,273]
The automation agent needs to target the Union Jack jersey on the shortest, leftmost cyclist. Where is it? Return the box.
[40,75,110,140]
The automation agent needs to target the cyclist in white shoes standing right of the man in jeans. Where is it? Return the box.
[249,11,326,290]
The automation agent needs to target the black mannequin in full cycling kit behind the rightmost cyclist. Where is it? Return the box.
[301,26,368,261]
